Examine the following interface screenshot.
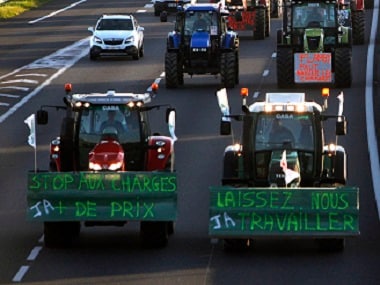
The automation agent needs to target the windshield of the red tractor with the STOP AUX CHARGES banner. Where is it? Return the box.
[79,105,141,144]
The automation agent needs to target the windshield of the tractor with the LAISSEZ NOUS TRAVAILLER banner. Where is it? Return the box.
[254,113,315,151]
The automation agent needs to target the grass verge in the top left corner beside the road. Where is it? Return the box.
[0,0,50,19]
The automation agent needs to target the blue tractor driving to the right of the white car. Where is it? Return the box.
[165,4,239,88]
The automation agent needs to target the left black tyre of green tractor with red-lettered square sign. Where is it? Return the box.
[276,46,294,88]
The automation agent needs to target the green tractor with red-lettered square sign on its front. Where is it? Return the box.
[277,0,352,88]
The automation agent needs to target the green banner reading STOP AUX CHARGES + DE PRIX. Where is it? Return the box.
[27,172,177,221]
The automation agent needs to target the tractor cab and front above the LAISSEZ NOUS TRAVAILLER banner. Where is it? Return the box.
[219,89,345,187]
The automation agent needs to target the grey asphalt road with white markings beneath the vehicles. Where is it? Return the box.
[0,0,380,285]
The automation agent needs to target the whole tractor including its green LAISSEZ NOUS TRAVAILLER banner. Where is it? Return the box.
[209,88,359,251]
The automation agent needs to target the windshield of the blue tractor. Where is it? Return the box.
[185,10,218,35]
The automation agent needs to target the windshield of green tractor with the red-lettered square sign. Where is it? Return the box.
[292,2,336,28]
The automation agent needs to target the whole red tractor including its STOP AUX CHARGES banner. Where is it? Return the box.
[27,84,177,247]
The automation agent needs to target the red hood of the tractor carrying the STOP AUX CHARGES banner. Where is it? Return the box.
[89,139,124,171]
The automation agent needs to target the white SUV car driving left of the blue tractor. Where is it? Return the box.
[88,15,144,60]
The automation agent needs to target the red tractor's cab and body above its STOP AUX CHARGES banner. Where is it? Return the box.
[37,83,175,171]
